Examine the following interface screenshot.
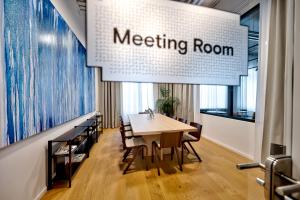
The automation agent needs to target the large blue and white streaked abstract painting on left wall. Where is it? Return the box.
[0,0,95,148]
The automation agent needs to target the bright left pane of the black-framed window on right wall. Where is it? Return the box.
[200,85,228,112]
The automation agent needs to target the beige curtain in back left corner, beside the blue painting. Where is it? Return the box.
[97,69,122,128]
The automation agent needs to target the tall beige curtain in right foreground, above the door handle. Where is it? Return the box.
[262,0,295,160]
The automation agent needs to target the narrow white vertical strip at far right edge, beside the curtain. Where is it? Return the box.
[292,1,300,180]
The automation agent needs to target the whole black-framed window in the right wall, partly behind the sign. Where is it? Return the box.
[200,5,259,121]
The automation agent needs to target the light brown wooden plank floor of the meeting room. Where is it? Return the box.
[43,129,264,200]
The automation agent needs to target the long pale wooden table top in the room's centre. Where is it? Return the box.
[128,113,197,136]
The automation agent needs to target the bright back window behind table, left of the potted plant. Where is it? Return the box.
[122,82,154,115]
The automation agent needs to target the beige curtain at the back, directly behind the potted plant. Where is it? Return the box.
[153,84,195,122]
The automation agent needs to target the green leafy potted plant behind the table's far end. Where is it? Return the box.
[156,87,179,117]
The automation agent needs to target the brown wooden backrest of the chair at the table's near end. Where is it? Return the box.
[160,132,183,148]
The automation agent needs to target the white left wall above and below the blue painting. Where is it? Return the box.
[0,0,94,200]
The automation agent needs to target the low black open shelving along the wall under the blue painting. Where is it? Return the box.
[48,115,103,190]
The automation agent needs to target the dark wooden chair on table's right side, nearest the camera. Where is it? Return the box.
[181,122,202,164]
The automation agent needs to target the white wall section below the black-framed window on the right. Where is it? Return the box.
[195,113,255,160]
